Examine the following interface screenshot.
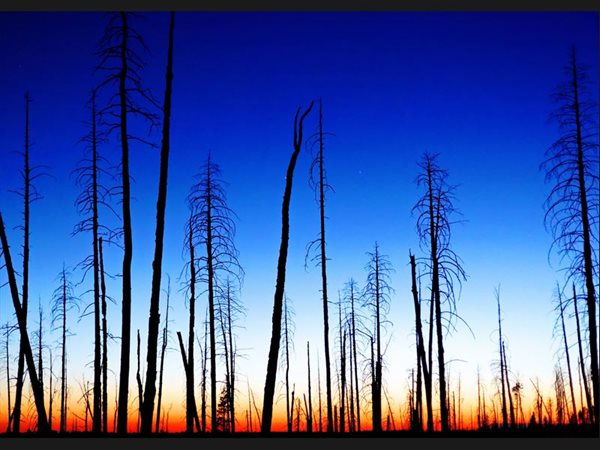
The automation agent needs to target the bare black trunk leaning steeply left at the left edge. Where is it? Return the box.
[0,213,49,433]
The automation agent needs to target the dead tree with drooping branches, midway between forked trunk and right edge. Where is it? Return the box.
[413,152,466,431]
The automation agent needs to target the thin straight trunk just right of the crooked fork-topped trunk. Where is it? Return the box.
[319,100,333,431]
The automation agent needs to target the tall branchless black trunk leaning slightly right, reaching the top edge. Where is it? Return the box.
[141,12,176,434]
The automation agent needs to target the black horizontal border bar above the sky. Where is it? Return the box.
[0,0,600,12]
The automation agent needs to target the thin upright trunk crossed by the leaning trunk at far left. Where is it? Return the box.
[13,92,31,433]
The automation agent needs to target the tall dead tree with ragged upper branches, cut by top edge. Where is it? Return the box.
[97,12,157,434]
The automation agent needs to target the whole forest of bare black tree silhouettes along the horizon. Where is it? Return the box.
[0,12,600,436]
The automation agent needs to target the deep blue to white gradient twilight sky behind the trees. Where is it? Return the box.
[0,12,599,427]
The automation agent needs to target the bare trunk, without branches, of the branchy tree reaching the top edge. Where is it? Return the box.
[117,12,133,434]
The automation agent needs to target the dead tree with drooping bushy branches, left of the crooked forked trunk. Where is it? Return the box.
[188,154,243,432]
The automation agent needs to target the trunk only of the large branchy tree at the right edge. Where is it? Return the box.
[572,50,600,423]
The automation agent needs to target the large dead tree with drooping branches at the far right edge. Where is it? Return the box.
[541,47,600,423]
